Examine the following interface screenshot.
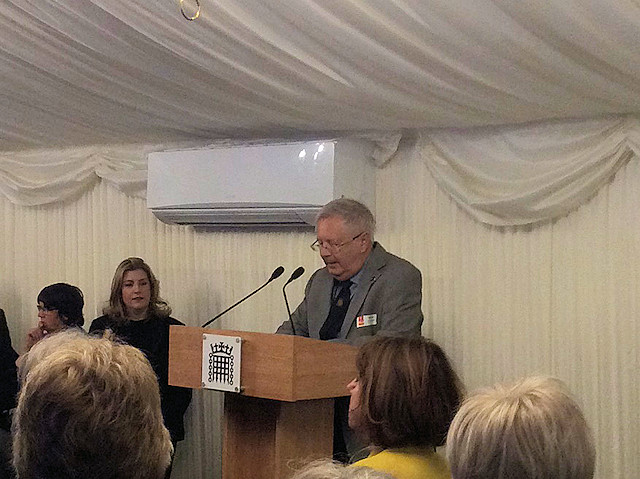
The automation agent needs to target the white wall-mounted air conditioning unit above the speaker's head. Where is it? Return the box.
[147,139,375,228]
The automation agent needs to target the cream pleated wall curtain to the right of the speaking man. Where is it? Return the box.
[376,149,640,479]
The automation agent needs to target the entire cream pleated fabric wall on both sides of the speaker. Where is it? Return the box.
[0,159,640,479]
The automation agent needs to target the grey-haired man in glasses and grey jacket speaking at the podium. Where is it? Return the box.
[276,198,423,460]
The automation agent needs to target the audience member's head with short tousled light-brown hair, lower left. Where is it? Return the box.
[13,330,172,479]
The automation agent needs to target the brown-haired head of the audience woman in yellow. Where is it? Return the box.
[348,337,462,449]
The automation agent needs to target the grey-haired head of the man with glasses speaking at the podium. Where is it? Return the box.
[312,198,375,281]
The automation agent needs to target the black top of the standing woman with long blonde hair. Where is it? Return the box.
[89,316,191,443]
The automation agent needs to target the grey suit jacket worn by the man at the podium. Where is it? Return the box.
[276,243,423,345]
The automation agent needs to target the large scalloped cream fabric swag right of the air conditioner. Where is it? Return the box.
[415,118,640,226]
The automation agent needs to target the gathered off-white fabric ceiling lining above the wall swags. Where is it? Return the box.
[0,0,640,151]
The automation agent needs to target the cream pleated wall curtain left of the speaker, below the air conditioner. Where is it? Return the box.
[0,182,320,479]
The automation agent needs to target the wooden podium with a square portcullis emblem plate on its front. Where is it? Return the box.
[169,326,357,479]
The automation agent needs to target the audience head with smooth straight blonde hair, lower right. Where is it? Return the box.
[447,377,595,479]
